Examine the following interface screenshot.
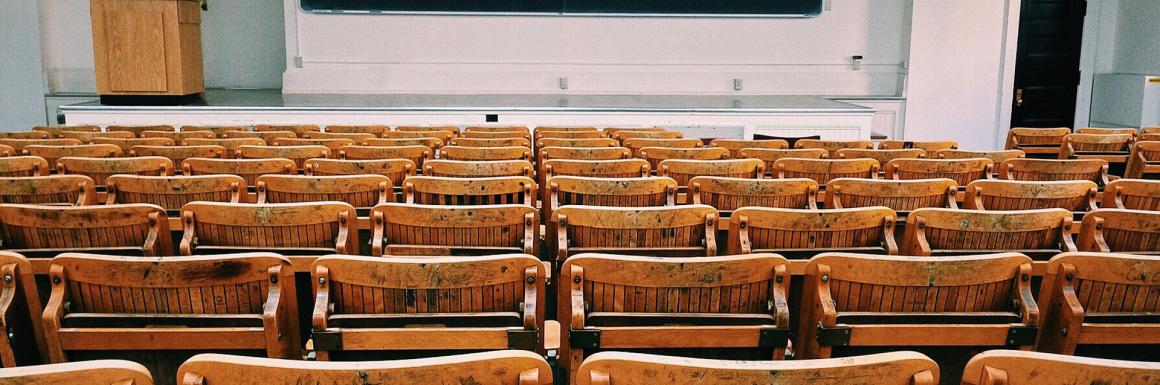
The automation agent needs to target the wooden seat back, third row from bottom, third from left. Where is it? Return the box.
[371,203,539,255]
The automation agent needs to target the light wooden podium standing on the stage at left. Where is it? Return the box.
[90,0,205,106]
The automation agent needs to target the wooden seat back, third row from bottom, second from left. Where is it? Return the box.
[180,202,360,255]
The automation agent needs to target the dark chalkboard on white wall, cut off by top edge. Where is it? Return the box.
[302,0,824,16]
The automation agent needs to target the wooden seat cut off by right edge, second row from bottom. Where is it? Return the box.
[1038,253,1160,355]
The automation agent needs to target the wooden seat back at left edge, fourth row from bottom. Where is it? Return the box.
[0,175,99,206]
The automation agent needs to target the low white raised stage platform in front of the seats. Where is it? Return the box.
[60,89,875,139]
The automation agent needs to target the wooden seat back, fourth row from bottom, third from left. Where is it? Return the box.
[256,174,394,209]
